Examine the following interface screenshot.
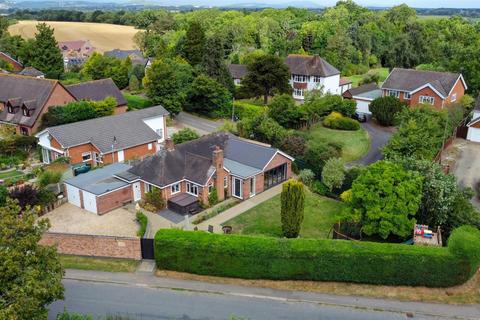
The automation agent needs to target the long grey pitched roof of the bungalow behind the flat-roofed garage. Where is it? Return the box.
[37,106,168,154]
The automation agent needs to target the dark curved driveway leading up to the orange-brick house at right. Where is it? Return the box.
[351,119,394,165]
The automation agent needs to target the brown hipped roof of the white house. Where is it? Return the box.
[285,54,340,77]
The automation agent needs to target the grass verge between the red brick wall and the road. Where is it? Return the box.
[60,255,140,272]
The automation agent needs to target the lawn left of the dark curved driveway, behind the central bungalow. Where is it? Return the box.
[305,123,370,162]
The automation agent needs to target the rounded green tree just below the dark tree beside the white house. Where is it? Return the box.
[268,94,305,128]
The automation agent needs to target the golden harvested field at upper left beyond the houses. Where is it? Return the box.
[8,20,138,53]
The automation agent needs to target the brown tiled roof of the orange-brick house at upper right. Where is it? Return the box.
[382,68,466,97]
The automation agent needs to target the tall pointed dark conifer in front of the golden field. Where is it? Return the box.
[29,23,63,79]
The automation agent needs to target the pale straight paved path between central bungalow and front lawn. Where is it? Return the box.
[197,184,282,233]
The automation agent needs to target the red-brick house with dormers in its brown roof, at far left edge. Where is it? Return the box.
[0,73,75,135]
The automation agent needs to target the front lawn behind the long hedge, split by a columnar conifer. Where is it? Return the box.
[223,190,344,239]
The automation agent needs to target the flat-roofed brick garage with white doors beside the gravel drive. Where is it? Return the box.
[64,163,135,214]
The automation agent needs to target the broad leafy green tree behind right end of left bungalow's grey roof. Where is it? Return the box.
[143,59,193,115]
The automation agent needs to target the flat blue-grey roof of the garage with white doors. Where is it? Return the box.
[65,163,131,195]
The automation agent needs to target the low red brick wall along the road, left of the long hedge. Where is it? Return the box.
[40,232,142,260]
